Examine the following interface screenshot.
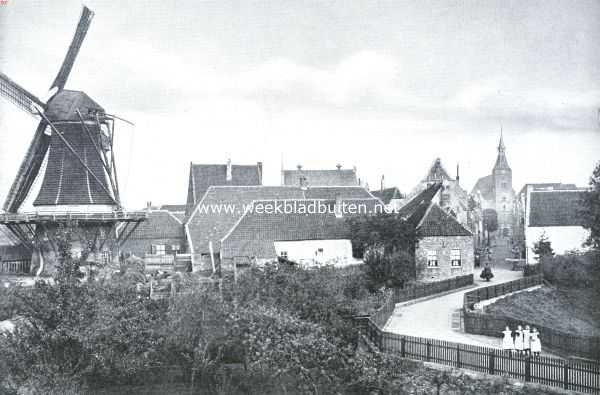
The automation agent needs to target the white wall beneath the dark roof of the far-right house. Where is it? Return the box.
[525,226,589,264]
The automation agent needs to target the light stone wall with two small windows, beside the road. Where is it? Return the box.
[415,236,474,282]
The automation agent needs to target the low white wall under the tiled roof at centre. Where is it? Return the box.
[274,240,356,266]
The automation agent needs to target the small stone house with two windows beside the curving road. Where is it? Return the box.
[399,183,474,282]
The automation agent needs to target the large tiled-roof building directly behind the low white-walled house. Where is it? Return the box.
[185,186,380,271]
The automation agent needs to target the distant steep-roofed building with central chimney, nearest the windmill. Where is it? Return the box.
[186,160,262,215]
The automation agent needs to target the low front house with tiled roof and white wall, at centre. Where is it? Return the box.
[221,198,380,266]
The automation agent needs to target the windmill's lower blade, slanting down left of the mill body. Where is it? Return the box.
[4,121,50,213]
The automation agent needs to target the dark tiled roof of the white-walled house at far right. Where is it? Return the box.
[529,190,587,227]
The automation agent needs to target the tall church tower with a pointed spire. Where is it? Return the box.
[492,130,515,237]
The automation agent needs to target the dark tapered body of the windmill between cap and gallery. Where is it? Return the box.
[33,123,114,206]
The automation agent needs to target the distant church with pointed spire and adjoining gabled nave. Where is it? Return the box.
[471,134,515,237]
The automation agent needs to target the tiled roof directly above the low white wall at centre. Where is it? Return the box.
[221,198,379,258]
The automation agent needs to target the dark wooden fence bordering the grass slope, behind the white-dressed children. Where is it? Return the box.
[463,275,600,360]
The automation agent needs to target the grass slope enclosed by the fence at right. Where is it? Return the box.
[485,287,600,336]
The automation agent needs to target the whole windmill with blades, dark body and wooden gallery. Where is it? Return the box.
[0,6,145,272]
